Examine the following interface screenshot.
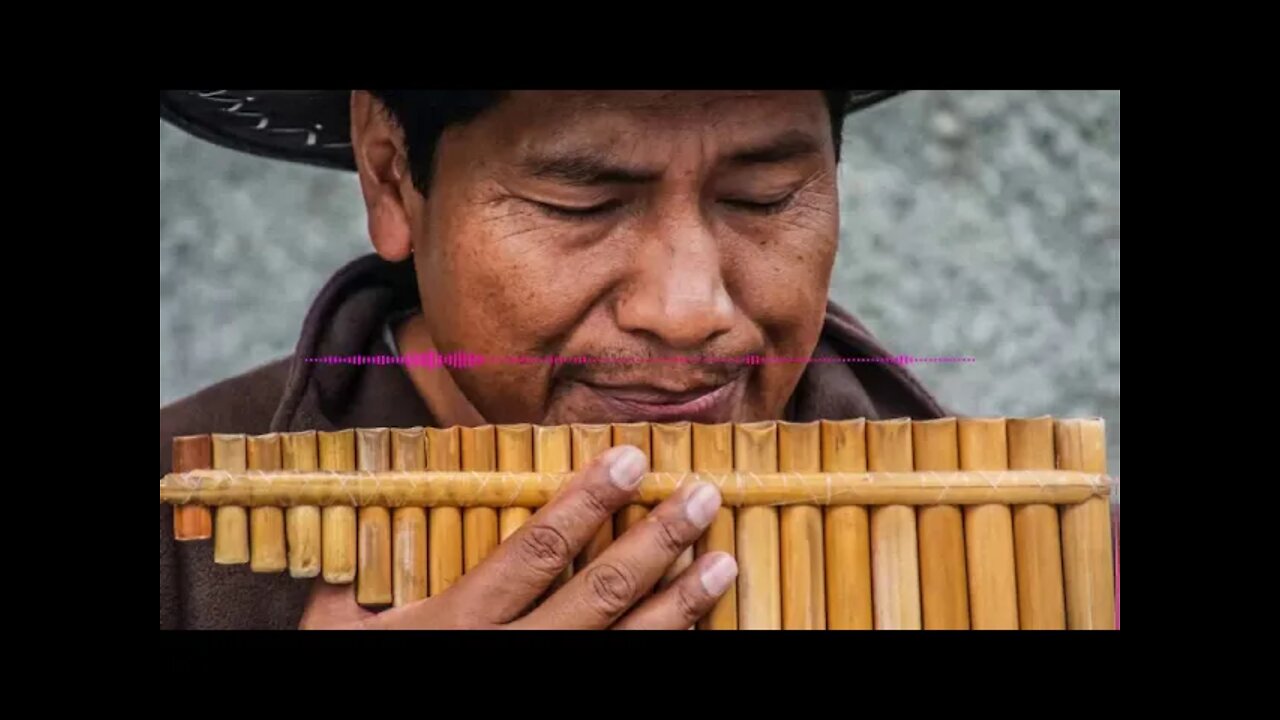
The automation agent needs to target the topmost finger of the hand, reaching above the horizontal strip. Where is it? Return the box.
[440,446,646,623]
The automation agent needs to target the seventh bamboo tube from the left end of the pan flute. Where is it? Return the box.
[392,428,428,607]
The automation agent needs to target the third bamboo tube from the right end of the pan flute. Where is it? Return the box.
[959,418,1018,630]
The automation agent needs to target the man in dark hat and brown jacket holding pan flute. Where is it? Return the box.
[160,91,943,629]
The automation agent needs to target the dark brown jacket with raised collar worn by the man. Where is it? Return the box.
[160,255,945,629]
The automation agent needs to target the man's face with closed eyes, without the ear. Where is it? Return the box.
[407,92,838,424]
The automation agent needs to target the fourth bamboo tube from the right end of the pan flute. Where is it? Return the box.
[911,418,969,630]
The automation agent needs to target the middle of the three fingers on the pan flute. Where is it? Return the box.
[521,483,721,629]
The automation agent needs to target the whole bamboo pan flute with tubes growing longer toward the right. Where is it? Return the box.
[160,418,1117,629]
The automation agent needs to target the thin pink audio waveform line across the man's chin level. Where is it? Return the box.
[306,352,977,368]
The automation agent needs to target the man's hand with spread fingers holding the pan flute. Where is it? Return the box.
[301,446,737,630]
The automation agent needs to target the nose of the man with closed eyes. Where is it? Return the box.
[616,212,735,351]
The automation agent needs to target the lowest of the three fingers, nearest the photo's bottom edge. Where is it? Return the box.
[613,552,737,630]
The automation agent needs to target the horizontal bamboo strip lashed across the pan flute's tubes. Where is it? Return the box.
[160,470,1110,507]
